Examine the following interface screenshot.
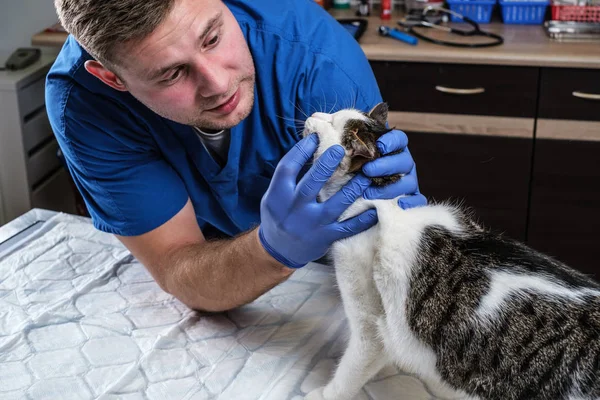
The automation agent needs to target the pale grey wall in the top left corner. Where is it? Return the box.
[0,0,58,52]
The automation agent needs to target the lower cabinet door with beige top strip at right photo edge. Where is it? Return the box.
[528,120,600,281]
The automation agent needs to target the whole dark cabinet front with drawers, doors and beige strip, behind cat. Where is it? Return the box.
[371,61,600,279]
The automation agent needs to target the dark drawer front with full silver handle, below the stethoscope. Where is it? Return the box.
[371,61,539,118]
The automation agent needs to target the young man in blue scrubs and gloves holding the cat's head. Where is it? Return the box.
[46,0,426,311]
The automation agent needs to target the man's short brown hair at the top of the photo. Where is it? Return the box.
[54,0,175,68]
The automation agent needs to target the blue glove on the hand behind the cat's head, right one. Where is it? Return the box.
[363,130,427,209]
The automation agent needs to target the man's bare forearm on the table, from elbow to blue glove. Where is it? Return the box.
[163,229,293,311]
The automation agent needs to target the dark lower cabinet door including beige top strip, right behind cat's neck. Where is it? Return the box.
[389,112,534,241]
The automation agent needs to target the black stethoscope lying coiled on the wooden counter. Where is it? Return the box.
[398,6,504,48]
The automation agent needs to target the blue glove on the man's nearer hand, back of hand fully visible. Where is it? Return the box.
[258,135,377,268]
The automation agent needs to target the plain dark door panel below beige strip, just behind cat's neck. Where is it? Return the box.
[407,132,532,241]
